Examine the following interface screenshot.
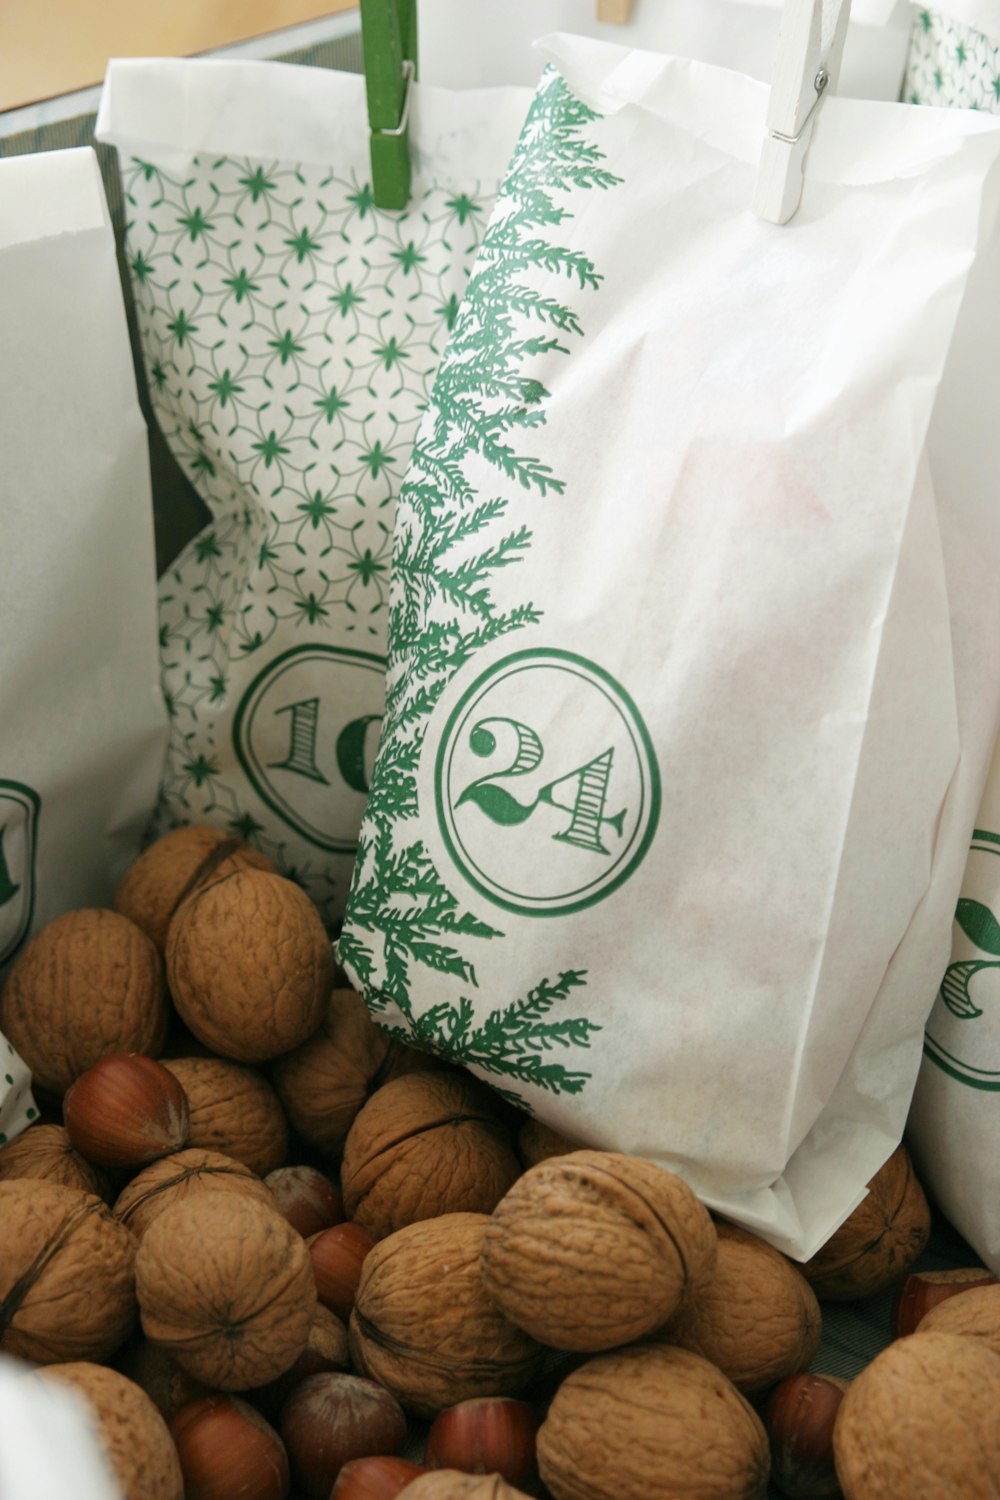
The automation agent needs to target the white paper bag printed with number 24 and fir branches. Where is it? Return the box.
[339,38,1000,1257]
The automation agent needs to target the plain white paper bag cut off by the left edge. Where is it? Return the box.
[0,150,166,972]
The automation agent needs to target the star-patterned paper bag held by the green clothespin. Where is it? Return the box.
[97,60,531,926]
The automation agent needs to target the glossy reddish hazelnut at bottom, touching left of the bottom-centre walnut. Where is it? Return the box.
[424,1397,538,1485]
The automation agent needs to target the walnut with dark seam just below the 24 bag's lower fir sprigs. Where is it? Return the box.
[340,1073,520,1239]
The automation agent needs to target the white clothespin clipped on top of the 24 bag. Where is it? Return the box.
[754,0,850,224]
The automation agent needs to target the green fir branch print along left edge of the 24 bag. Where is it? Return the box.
[339,72,619,1098]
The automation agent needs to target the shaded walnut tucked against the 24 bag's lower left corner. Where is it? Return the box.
[270,990,435,1157]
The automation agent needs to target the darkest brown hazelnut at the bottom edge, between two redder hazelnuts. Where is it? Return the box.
[279,1374,406,1500]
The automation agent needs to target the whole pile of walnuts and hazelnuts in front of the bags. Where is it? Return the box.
[0,828,1000,1500]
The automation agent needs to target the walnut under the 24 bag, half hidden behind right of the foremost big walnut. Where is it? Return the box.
[652,1224,822,1397]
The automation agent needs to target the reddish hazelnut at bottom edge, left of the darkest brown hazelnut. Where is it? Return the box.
[169,1395,289,1500]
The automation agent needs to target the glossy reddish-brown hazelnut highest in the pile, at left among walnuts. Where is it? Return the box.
[63,1053,187,1167]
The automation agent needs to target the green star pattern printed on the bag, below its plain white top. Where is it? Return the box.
[121,152,495,927]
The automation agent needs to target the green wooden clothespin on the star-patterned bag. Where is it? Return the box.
[361,0,417,209]
